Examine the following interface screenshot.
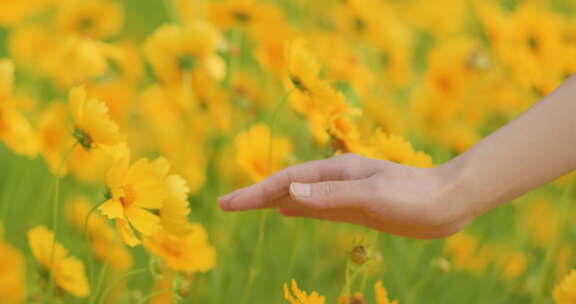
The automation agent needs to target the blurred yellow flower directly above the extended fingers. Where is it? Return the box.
[234,124,292,181]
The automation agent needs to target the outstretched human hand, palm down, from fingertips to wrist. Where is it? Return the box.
[219,154,471,239]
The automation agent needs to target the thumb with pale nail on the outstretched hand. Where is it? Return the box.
[290,179,374,209]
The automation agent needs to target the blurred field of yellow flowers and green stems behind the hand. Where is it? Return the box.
[0,0,576,303]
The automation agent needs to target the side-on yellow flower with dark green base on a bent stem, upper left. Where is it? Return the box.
[69,87,122,150]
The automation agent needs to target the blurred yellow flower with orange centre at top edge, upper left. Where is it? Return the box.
[56,0,124,39]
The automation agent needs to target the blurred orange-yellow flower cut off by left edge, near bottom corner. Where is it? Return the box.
[0,232,26,304]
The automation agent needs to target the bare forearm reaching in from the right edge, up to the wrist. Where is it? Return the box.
[440,76,576,216]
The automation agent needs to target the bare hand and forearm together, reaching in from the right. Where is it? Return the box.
[218,76,576,239]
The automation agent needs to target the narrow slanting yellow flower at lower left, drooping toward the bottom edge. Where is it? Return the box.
[28,226,90,298]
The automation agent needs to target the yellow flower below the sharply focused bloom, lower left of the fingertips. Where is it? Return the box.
[143,224,216,273]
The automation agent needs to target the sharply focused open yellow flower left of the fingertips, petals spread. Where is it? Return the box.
[98,148,168,246]
